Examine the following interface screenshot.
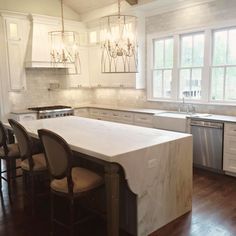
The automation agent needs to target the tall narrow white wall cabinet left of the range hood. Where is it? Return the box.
[4,16,29,91]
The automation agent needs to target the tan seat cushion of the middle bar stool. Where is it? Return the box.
[21,153,47,171]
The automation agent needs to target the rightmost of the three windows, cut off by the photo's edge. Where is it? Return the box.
[211,28,236,101]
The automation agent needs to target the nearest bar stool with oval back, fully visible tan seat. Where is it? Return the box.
[38,129,103,236]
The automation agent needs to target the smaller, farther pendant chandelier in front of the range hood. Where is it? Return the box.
[49,0,80,74]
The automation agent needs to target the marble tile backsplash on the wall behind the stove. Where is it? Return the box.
[9,69,92,110]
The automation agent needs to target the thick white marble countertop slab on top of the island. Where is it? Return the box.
[6,116,190,162]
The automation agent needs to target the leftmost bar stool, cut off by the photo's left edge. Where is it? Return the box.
[0,121,22,196]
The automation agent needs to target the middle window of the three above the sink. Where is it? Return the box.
[179,33,205,99]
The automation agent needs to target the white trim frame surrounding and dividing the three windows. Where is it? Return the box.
[146,20,236,106]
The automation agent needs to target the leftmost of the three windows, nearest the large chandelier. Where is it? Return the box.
[152,38,173,98]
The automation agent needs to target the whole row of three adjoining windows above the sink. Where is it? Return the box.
[147,25,236,105]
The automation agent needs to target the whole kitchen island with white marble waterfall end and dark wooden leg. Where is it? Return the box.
[6,116,192,236]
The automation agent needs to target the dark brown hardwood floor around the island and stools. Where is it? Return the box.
[0,169,236,236]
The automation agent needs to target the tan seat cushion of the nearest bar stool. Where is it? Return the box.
[51,167,103,193]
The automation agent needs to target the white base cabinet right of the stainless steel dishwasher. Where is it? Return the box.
[223,123,236,174]
